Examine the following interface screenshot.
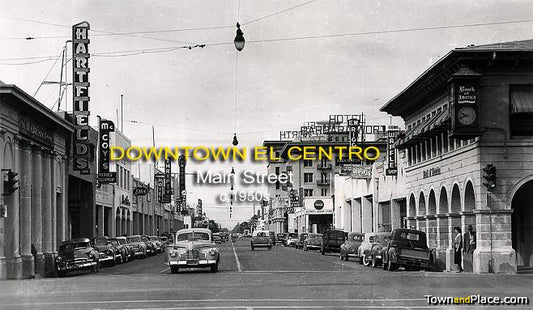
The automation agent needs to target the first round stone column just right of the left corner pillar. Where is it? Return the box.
[19,141,35,278]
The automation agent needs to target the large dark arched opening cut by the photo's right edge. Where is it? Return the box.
[511,180,533,272]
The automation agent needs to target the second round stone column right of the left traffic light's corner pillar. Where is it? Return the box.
[31,146,44,275]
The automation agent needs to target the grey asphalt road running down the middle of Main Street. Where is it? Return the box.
[0,240,533,309]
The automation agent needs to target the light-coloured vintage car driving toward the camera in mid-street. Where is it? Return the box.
[166,228,220,273]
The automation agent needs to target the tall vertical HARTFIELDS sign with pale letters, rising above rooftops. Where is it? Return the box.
[72,22,91,174]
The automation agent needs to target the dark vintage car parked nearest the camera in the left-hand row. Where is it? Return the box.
[55,238,99,277]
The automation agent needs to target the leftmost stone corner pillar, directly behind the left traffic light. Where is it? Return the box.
[4,137,22,279]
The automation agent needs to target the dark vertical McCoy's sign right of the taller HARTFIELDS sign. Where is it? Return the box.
[98,117,117,184]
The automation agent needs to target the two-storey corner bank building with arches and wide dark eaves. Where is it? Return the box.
[381,40,533,273]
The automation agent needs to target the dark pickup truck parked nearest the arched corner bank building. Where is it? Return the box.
[382,228,435,271]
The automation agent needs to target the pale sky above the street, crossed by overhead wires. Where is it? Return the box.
[0,0,533,228]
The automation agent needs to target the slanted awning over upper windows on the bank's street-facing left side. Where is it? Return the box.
[395,109,450,149]
